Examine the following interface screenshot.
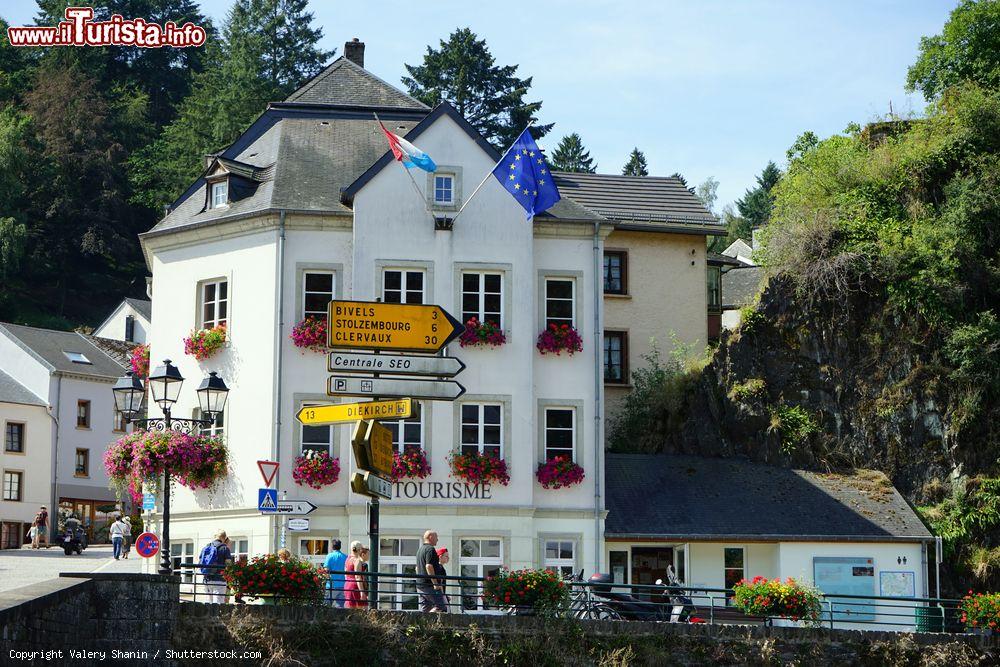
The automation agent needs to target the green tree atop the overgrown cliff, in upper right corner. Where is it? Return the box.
[906,0,1000,100]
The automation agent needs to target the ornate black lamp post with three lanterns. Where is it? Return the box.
[112,359,229,574]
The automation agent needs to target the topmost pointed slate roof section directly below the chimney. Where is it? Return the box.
[285,56,430,111]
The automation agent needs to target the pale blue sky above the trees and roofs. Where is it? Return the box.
[7,0,957,211]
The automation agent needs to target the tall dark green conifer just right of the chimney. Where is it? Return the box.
[402,28,552,149]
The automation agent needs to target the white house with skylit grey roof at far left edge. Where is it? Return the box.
[0,323,127,548]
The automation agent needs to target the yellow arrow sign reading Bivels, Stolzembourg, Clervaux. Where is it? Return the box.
[327,301,465,352]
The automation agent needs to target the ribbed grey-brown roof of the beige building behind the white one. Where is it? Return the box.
[552,171,724,230]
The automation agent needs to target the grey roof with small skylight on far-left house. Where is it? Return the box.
[0,322,125,378]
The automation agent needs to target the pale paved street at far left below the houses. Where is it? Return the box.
[0,545,142,591]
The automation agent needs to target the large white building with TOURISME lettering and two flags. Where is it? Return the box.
[141,44,611,596]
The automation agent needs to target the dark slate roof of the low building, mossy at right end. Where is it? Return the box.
[604,453,931,542]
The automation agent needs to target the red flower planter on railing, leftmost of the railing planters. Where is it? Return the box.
[222,554,330,604]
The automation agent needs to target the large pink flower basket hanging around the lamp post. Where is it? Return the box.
[104,431,229,502]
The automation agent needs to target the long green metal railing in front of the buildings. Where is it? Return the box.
[180,563,964,633]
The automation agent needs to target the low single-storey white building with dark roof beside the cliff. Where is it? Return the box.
[605,454,934,629]
